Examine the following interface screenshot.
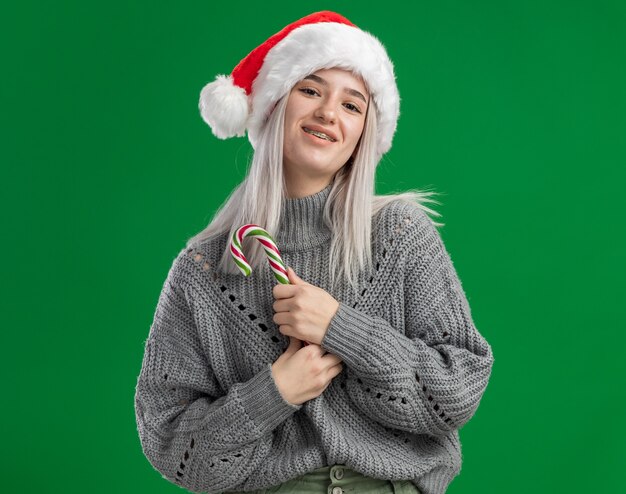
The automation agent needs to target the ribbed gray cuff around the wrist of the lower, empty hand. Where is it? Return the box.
[239,363,302,432]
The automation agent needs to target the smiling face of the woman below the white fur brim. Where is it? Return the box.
[283,68,369,197]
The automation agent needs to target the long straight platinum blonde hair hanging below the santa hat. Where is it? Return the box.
[187,86,443,291]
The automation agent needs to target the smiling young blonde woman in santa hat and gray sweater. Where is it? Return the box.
[135,12,493,494]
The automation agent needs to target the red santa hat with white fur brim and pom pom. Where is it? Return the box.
[199,11,400,157]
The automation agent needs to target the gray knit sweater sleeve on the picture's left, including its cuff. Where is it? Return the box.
[134,268,301,493]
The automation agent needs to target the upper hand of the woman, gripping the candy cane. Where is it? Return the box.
[272,268,339,345]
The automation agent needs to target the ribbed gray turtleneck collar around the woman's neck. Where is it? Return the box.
[276,183,332,252]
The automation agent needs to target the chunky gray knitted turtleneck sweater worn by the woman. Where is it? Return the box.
[134,186,493,494]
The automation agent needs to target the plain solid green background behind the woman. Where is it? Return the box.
[0,0,626,494]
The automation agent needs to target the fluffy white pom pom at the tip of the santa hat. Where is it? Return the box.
[198,75,249,139]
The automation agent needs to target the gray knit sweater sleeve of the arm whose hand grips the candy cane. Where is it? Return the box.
[322,209,493,434]
